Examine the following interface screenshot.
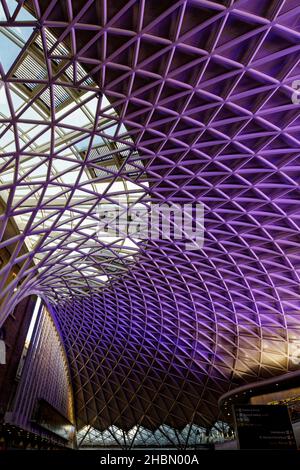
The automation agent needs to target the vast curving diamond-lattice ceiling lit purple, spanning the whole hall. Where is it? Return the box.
[0,0,300,429]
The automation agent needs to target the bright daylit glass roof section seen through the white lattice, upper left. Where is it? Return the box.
[0,14,143,294]
